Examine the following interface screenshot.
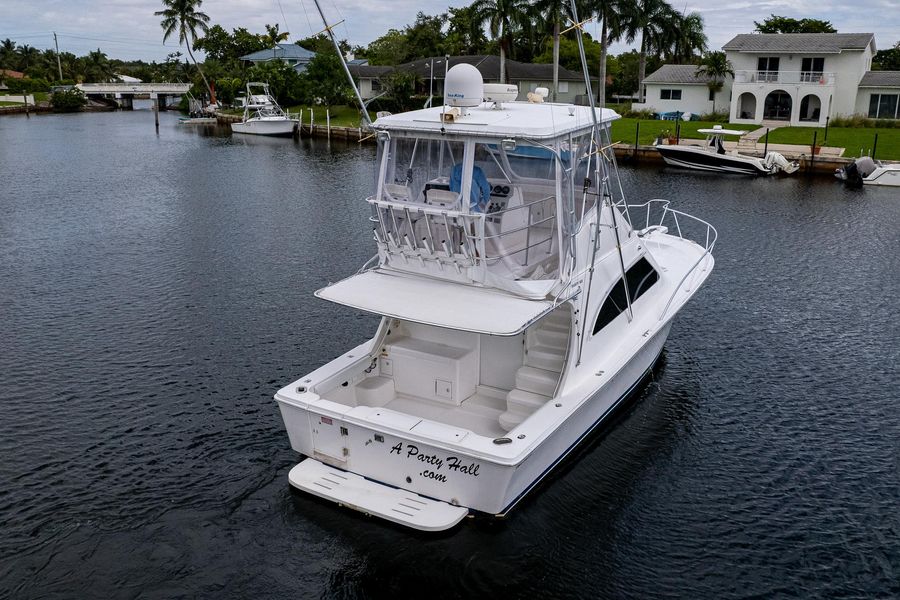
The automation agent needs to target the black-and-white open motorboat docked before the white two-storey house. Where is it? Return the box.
[655,125,799,175]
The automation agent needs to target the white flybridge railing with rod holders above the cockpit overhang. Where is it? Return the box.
[367,196,559,283]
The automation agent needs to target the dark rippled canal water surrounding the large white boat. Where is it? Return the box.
[0,111,900,598]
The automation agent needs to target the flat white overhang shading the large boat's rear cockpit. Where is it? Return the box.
[316,270,553,336]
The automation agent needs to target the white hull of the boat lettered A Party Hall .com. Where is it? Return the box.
[276,323,671,515]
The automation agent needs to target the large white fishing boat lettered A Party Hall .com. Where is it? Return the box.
[275,57,716,531]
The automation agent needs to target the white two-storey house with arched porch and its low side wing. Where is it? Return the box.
[635,33,900,126]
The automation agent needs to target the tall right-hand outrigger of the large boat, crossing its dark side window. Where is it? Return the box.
[567,0,634,364]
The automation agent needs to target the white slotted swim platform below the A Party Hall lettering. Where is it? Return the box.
[288,458,469,531]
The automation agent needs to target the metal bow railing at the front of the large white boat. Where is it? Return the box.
[629,199,719,320]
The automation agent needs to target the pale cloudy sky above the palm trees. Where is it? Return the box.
[0,0,900,61]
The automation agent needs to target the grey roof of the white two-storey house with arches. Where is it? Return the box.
[722,33,875,54]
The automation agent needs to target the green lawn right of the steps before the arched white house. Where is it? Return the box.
[760,127,900,160]
